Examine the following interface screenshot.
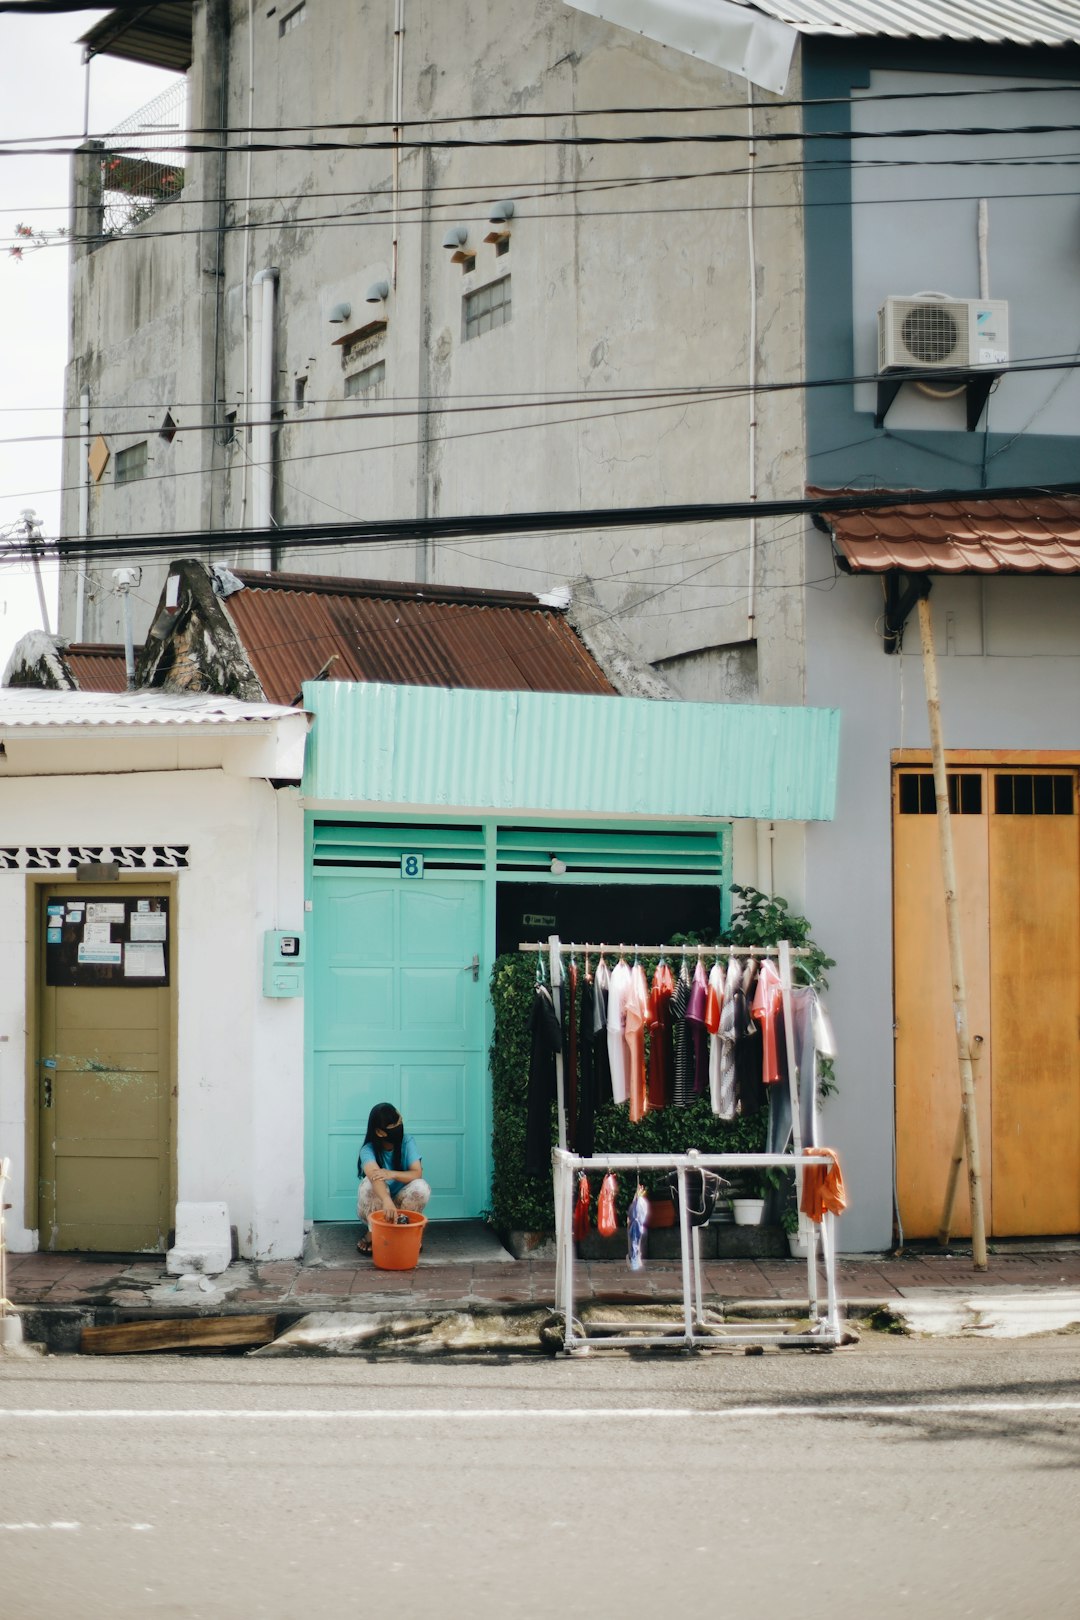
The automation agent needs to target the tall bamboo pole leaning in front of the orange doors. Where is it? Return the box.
[918,596,986,1272]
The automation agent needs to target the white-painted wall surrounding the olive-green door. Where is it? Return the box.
[0,764,303,1259]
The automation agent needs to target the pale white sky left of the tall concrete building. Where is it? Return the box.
[0,10,175,671]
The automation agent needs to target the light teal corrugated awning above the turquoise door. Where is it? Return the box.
[303,680,840,821]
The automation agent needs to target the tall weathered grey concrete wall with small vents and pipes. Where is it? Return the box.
[63,0,803,701]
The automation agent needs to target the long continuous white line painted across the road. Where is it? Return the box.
[0,1400,1080,1424]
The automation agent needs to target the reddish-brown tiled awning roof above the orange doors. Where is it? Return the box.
[808,488,1080,573]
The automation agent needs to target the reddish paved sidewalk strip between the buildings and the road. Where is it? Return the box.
[8,1246,1080,1315]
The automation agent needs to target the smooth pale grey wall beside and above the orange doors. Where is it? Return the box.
[806,533,1080,1251]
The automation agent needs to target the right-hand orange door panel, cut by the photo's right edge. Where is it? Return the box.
[989,771,1080,1236]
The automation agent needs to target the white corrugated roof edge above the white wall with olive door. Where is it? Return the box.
[0,687,304,732]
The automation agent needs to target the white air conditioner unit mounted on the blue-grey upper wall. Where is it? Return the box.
[878,293,1009,371]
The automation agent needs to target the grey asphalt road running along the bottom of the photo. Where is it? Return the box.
[0,1337,1080,1620]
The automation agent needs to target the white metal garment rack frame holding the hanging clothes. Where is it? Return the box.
[518,935,842,1354]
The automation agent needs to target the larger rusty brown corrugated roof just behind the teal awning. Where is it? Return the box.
[222,570,615,703]
